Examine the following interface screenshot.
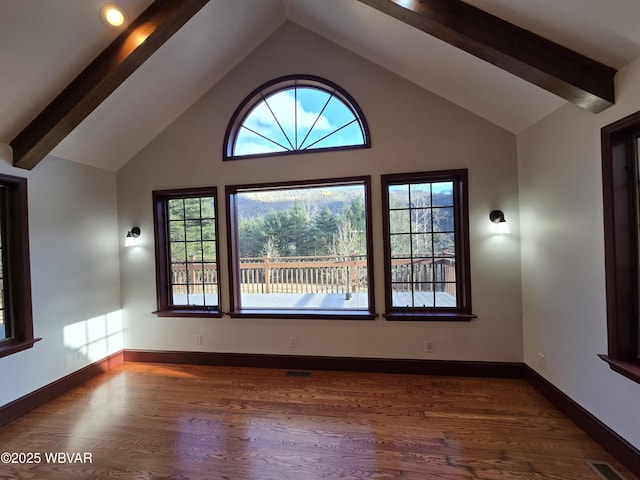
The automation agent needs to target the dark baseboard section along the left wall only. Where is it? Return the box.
[0,350,124,427]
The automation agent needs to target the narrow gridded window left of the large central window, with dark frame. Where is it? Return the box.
[153,187,221,316]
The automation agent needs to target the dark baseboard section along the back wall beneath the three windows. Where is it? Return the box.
[124,350,523,378]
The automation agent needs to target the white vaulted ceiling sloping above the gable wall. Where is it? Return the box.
[0,0,640,171]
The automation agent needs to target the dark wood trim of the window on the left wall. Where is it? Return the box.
[0,175,41,357]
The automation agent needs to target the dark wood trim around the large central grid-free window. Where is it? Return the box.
[225,176,377,320]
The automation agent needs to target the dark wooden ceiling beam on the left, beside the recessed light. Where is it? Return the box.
[11,0,209,170]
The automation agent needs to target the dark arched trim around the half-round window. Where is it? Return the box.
[222,75,371,160]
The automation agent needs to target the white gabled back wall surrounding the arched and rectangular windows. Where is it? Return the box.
[117,23,522,362]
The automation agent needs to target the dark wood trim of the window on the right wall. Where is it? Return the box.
[600,112,640,383]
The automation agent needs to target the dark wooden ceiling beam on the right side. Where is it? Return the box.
[359,0,616,113]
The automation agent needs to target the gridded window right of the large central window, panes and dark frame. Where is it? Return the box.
[382,170,474,320]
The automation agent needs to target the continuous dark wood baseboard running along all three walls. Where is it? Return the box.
[0,350,640,477]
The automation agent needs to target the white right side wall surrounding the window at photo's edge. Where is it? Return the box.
[518,61,640,448]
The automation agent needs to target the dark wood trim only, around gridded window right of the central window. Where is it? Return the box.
[382,169,476,322]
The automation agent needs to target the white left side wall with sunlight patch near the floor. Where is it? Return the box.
[0,157,124,406]
